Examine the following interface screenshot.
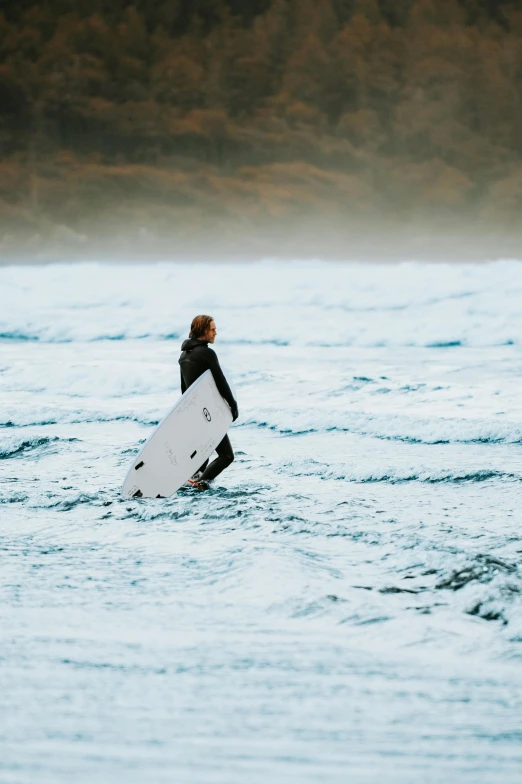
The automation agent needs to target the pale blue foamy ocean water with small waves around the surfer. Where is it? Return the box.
[0,261,522,784]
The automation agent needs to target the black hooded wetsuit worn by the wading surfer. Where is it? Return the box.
[179,338,238,482]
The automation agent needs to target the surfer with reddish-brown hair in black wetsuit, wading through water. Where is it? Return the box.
[179,316,239,490]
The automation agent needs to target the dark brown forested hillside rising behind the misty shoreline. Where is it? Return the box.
[0,0,522,258]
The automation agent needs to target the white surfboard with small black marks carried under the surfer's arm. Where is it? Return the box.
[121,370,232,498]
